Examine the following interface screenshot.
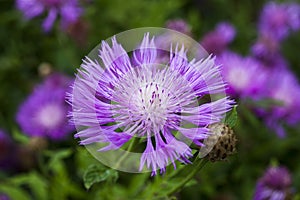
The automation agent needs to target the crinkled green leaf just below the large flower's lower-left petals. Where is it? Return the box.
[83,165,119,189]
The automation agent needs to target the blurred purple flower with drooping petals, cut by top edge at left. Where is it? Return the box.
[16,0,82,32]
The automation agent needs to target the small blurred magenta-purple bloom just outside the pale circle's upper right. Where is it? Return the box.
[200,22,236,54]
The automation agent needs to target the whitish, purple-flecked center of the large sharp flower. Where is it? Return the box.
[113,67,192,135]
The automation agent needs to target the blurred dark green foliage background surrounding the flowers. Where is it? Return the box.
[0,0,300,199]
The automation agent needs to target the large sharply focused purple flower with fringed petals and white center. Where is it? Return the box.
[69,34,234,175]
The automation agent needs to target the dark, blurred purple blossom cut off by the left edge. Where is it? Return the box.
[0,130,16,172]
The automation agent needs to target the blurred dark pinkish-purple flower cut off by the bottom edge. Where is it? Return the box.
[253,167,292,200]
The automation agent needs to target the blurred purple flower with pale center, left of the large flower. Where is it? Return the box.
[16,74,74,140]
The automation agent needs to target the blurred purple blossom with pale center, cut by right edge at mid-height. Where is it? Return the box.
[265,69,300,137]
